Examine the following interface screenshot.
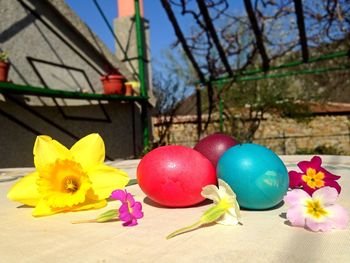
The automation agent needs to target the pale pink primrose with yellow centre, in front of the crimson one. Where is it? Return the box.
[283,186,349,232]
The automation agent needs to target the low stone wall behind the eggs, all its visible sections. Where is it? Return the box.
[154,115,350,155]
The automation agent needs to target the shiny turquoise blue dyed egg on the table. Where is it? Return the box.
[217,143,289,210]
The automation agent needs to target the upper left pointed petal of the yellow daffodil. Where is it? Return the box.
[33,135,71,172]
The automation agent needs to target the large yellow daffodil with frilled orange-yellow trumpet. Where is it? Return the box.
[7,133,129,217]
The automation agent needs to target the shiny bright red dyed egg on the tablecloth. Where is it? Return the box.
[137,145,217,207]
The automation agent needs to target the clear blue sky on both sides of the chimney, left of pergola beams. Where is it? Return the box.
[66,0,182,66]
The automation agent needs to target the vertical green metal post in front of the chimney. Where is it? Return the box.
[135,0,149,149]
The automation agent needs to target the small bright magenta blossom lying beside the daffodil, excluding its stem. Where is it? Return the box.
[111,190,143,226]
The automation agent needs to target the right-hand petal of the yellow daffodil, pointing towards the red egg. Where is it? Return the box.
[88,164,129,200]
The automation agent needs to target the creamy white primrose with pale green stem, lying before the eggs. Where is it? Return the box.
[167,179,241,239]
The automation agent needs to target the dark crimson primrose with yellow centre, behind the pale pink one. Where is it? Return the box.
[288,156,341,195]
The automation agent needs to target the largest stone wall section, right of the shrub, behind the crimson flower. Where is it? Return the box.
[254,116,350,154]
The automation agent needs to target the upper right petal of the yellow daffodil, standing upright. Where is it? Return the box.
[70,133,105,170]
